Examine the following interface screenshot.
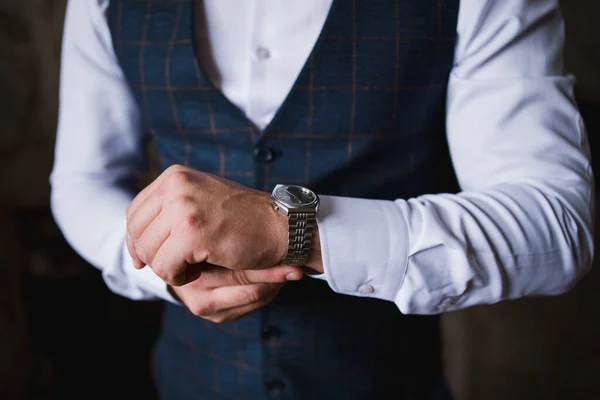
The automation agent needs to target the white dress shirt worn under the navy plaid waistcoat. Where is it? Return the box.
[51,0,593,314]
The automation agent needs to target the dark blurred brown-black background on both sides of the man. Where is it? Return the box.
[0,0,600,400]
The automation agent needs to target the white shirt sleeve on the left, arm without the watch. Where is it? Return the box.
[50,0,176,303]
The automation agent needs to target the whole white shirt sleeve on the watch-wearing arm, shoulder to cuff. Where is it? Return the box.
[317,0,594,314]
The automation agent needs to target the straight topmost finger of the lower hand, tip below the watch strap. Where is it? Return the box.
[200,263,303,289]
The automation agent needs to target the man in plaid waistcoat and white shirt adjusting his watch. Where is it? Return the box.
[52,0,593,399]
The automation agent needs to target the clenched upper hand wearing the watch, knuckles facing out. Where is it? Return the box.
[127,165,322,286]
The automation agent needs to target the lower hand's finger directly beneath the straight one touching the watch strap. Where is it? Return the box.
[190,283,280,317]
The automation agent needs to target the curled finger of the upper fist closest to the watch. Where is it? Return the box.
[149,235,202,286]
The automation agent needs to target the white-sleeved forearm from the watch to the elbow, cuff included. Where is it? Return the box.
[312,172,593,314]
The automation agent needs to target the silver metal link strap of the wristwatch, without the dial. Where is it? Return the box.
[281,212,317,266]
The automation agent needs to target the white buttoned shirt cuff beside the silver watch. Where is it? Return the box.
[313,196,408,301]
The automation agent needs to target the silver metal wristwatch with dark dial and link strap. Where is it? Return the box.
[271,185,319,266]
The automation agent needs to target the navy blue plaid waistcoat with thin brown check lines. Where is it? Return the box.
[109,0,458,400]
